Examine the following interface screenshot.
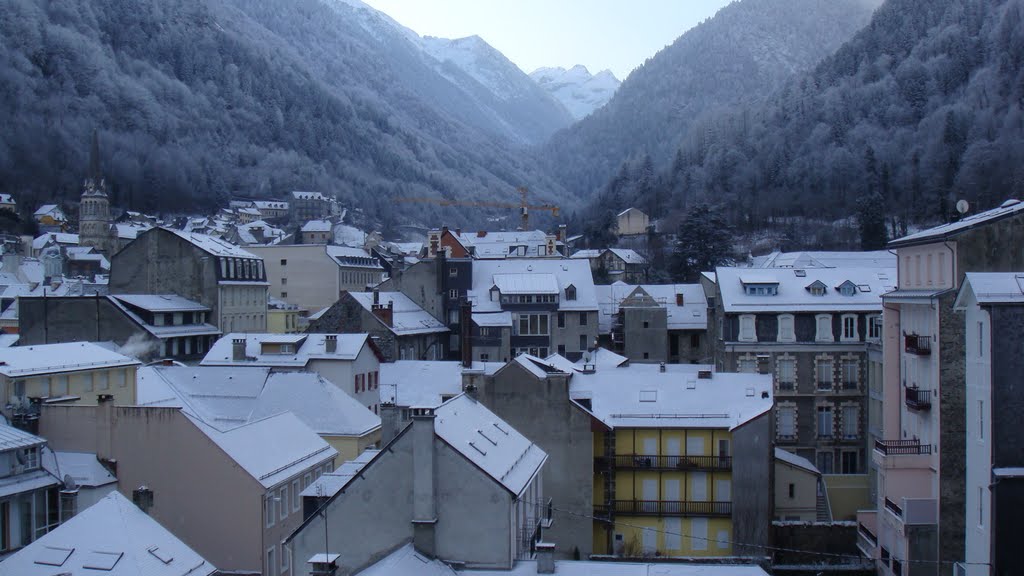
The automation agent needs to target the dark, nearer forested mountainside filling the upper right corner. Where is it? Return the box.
[595,0,1024,247]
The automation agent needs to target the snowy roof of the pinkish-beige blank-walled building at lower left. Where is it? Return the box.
[182,410,338,488]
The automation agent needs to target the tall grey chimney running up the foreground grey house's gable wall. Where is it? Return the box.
[410,407,437,558]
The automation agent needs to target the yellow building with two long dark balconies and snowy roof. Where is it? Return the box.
[570,365,773,557]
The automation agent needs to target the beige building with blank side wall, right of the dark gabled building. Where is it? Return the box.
[248,244,384,312]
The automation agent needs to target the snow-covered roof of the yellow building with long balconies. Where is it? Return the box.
[569,364,773,429]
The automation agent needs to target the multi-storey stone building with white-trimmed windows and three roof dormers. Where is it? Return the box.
[715,268,895,477]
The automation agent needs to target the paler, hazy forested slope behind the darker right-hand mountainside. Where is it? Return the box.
[544,0,880,199]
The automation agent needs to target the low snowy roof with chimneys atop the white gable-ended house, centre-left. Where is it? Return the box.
[201,332,368,367]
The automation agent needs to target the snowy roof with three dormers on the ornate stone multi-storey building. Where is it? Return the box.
[716,268,896,313]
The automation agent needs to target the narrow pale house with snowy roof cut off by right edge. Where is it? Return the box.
[953,272,1024,576]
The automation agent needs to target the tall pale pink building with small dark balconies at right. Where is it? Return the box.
[857,200,1024,576]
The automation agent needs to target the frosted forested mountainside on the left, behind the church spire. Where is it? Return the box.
[0,0,572,223]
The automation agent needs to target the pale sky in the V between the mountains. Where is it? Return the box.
[364,0,732,80]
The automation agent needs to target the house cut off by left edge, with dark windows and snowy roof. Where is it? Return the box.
[0,423,63,553]
